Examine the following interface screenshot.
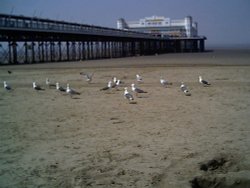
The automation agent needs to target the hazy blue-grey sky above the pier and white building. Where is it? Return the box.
[0,0,250,46]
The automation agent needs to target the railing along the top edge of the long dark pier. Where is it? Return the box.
[0,14,160,40]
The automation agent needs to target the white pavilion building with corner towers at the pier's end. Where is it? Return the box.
[117,16,198,38]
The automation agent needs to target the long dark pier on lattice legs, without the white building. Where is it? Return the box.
[0,14,206,64]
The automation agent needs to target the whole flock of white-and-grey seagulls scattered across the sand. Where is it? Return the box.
[3,71,210,102]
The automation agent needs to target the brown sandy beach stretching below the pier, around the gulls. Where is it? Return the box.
[0,50,250,188]
